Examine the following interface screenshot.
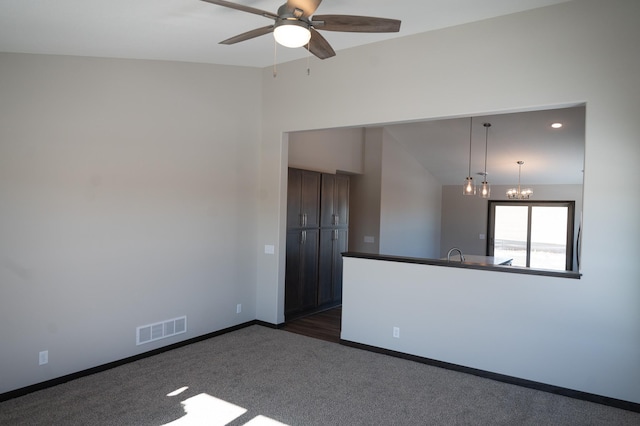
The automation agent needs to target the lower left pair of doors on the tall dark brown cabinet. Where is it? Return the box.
[284,229,319,315]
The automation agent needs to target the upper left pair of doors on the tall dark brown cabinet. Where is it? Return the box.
[287,169,320,229]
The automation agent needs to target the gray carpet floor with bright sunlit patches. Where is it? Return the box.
[0,325,640,426]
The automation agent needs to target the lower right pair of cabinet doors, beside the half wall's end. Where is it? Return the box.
[318,228,348,305]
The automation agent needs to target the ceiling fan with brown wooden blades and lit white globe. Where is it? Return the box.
[203,0,400,59]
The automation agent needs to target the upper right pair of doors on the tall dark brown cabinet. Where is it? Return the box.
[320,174,349,227]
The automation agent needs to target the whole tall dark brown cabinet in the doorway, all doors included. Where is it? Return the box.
[285,169,349,319]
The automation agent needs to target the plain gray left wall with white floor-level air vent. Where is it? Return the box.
[0,53,261,393]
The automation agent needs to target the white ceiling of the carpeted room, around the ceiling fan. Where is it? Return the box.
[0,0,567,67]
